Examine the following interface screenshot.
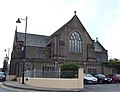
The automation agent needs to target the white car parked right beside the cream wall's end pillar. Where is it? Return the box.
[84,74,98,84]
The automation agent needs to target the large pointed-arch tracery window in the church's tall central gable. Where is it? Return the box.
[70,31,82,53]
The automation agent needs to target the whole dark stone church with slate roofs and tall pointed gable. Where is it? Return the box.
[10,13,108,76]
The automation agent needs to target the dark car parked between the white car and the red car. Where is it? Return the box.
[93,74,112,83]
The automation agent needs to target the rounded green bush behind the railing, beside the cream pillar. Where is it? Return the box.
[60,63,80,78]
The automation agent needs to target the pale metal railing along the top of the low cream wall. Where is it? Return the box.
[25,70,78,78]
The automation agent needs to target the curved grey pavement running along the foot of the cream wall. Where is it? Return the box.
[3,81,83,92]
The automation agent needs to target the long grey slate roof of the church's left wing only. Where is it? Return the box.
[17,32,50,47]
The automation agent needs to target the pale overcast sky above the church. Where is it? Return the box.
[0,0,120,67]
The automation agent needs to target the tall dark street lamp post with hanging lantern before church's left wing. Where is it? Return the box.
[16,16,28,84]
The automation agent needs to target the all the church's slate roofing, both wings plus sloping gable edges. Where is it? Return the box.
[16,14,106,52]
